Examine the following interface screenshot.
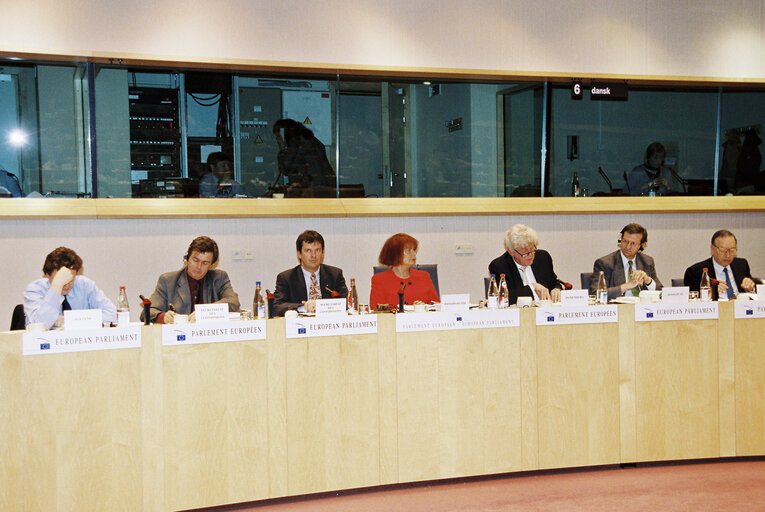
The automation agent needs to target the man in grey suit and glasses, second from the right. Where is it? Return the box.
[590,223,661,300]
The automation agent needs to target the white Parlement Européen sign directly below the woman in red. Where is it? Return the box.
[396,308,521,332]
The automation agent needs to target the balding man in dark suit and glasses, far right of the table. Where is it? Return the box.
[683,229,755,300]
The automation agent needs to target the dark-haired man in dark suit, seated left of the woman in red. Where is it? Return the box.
[274,231,348,316]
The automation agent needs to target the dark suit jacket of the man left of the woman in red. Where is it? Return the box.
[273,264,348,316]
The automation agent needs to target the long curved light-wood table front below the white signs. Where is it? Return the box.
[0,303,765,511]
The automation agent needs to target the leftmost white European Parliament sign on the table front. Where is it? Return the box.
[21,325,141,356]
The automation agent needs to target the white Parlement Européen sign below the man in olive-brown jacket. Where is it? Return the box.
[162,322,266,346]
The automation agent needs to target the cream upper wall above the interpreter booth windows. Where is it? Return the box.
[0,0,765,79]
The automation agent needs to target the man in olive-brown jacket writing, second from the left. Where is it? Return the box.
[141,236,239,324]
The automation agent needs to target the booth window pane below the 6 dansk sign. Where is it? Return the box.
[550,87,730,196]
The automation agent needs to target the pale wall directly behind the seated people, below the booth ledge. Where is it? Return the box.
[0,212,765,330]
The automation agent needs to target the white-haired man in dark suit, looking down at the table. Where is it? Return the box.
[489,224,563,304]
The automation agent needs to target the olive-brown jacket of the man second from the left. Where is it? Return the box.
[141,266,239,322]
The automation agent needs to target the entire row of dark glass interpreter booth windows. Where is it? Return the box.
[0,59,765,198]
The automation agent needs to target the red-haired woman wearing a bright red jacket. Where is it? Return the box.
[369,233,439,309]
